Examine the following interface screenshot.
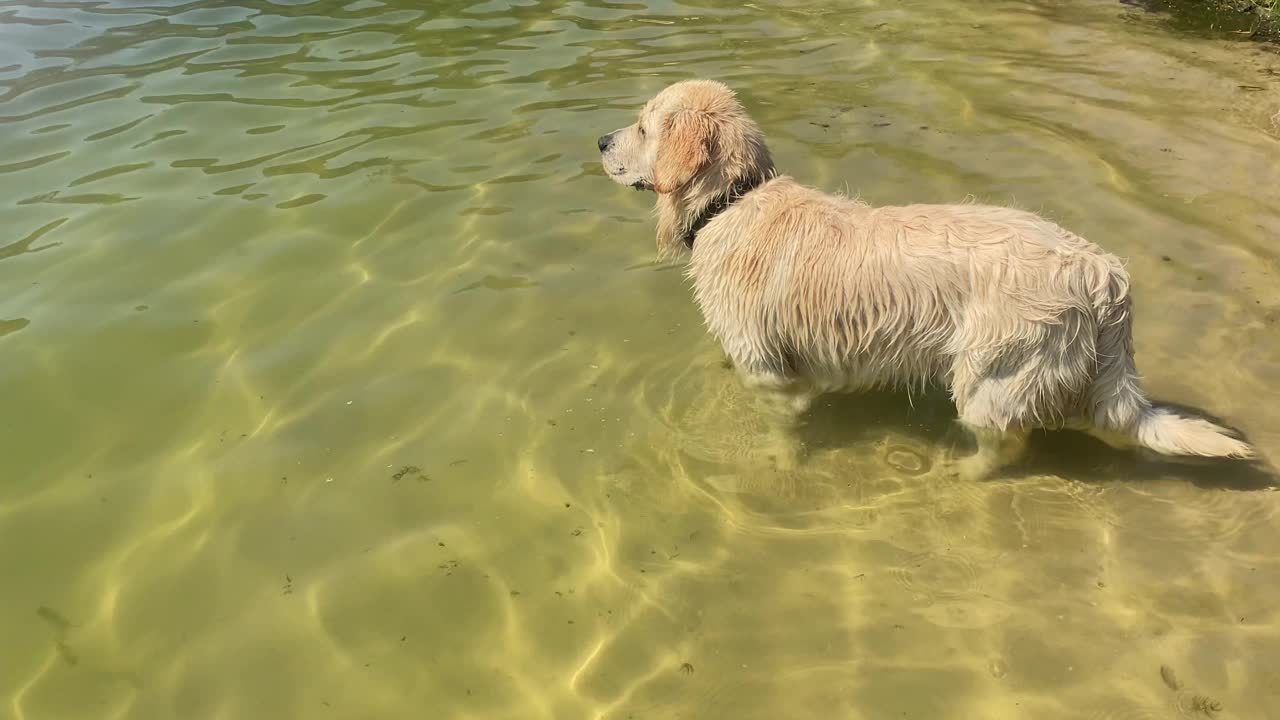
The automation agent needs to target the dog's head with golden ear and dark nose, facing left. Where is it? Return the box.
[598,79,773,197]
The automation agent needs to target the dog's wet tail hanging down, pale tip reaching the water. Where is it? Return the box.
[1089,282,1254,459]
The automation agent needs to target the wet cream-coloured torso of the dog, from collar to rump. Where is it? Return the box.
[690,177,1128,402]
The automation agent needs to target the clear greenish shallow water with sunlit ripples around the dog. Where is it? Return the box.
[0,0,1280,720]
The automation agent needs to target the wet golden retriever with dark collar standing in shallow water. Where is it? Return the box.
[598,79,1253,478]
